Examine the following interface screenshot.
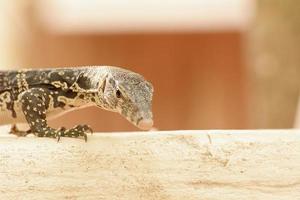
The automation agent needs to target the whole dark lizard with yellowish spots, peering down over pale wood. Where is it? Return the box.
[0,66,153,138]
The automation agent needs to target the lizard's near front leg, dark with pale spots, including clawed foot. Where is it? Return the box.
[21,88,92,141]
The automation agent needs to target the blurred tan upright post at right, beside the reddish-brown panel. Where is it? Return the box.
[248,0,300,128]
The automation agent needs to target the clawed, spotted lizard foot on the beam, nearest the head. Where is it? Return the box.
[57,125,93,142]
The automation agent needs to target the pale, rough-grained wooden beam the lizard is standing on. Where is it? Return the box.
[0,128,300,200]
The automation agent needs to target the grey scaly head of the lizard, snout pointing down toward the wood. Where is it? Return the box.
[100,68,153,130]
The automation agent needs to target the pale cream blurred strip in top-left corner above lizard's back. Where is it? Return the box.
[0,0,35,69]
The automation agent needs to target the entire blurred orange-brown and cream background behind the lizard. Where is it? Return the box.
[0,0,300,131]
